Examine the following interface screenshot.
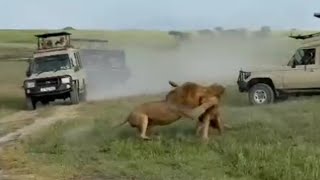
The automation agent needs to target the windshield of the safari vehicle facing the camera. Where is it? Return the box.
[31,54,71,73]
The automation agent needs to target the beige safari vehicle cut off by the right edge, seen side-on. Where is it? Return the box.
[237,30,320,105]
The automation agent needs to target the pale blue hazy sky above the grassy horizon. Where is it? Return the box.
[0,0,320,30]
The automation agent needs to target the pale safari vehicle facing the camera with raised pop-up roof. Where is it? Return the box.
[23,32,87,110]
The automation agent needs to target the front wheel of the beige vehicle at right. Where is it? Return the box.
[248,83,275,105]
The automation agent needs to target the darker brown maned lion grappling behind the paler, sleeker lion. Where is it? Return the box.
[166,81,231,138]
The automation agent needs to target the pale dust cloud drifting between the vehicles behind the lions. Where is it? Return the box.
[88,34,298,100]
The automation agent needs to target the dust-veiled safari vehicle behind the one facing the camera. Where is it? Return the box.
[71,38,131,88]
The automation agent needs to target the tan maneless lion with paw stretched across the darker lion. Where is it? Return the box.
[114,97,218,140]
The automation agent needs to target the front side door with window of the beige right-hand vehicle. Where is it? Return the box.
[283,48,320,90]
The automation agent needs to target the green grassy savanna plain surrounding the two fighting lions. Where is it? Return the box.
[0,31,320,180]
